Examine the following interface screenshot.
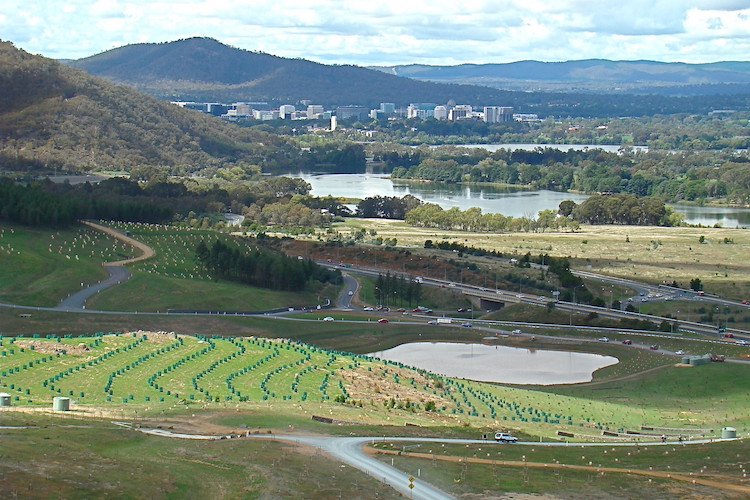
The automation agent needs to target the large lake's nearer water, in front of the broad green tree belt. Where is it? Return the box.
[294,174,750,227]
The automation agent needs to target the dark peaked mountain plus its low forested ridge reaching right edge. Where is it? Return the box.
[68,38,748,117]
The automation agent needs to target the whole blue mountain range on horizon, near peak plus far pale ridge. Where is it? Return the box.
[66,38,750,117]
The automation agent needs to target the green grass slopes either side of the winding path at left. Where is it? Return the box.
[0,223,338,312]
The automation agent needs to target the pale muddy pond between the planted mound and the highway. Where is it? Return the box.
[370,342,618,385]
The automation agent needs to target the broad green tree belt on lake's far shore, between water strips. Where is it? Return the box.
[378,143,750,203]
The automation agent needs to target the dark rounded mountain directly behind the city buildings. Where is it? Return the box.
[69,38,520,106]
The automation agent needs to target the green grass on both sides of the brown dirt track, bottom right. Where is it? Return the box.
[373,441,750,499]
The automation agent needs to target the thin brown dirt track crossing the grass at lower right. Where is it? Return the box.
[376,448,750,496]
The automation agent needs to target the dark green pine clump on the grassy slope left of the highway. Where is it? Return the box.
[195,239,342,291]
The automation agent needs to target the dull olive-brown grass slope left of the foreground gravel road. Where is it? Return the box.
[0,412,400,500]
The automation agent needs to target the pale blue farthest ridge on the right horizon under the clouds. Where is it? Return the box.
[370,59,750,95]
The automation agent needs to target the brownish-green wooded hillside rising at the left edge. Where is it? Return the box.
[0,41,290,173]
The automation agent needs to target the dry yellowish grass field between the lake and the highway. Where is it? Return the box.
[328,219,750,300]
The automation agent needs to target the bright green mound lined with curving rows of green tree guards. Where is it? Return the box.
[0,332,728,434]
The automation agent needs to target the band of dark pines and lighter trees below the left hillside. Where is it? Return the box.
[0,177,351,231]
